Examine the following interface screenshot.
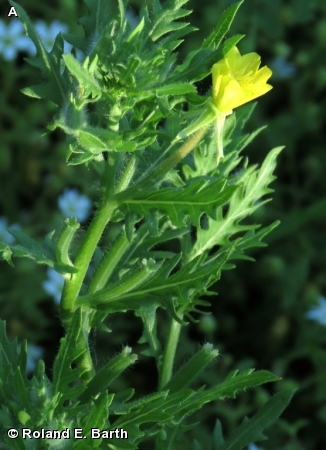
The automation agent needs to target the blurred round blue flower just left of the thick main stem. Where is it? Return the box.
[58,189,92,222]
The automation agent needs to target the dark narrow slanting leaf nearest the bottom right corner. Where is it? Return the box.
[219,389,295,450]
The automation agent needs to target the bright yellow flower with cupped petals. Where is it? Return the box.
[212,47,272,115]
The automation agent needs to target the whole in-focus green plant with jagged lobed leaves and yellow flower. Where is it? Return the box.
[0,0,292,450]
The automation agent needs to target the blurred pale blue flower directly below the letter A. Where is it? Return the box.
[0,19,32,61]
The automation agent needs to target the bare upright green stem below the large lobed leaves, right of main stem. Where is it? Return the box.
[159,314,183,391]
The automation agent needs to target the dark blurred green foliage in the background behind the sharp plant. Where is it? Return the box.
[0,0,326,450]
